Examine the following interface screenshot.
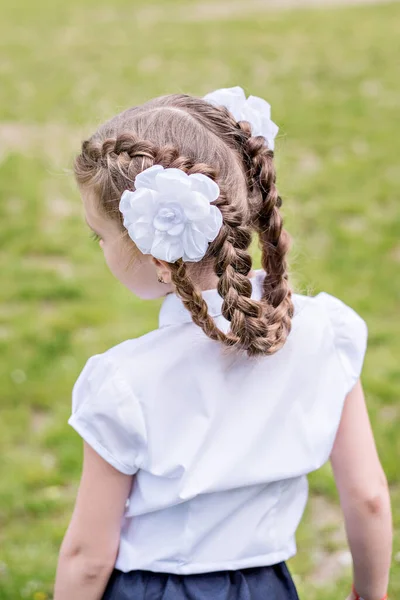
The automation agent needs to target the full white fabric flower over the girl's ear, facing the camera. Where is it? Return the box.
[119,165,222,263]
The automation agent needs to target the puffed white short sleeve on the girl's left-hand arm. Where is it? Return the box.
[68,353,146,475]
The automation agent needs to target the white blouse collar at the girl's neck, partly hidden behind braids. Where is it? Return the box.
[159,269,265,327]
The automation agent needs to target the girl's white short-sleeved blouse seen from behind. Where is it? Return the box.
[68,271,367,574]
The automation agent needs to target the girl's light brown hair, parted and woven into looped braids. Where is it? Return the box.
[74,94,294,356]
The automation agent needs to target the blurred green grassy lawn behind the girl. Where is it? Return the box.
[0,0,400,600]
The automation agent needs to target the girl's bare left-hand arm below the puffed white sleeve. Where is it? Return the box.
[54,442,132,600]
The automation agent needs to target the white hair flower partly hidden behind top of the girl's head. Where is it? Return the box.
[204,86,279,150]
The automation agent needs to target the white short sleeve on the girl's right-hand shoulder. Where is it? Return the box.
[316,292,368,393]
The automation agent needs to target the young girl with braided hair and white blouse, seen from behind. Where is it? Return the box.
[55,88,391,600]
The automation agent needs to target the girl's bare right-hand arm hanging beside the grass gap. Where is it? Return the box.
[331,380,392,600]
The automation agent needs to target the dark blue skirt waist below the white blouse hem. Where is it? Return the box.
[102,562,299,600]
